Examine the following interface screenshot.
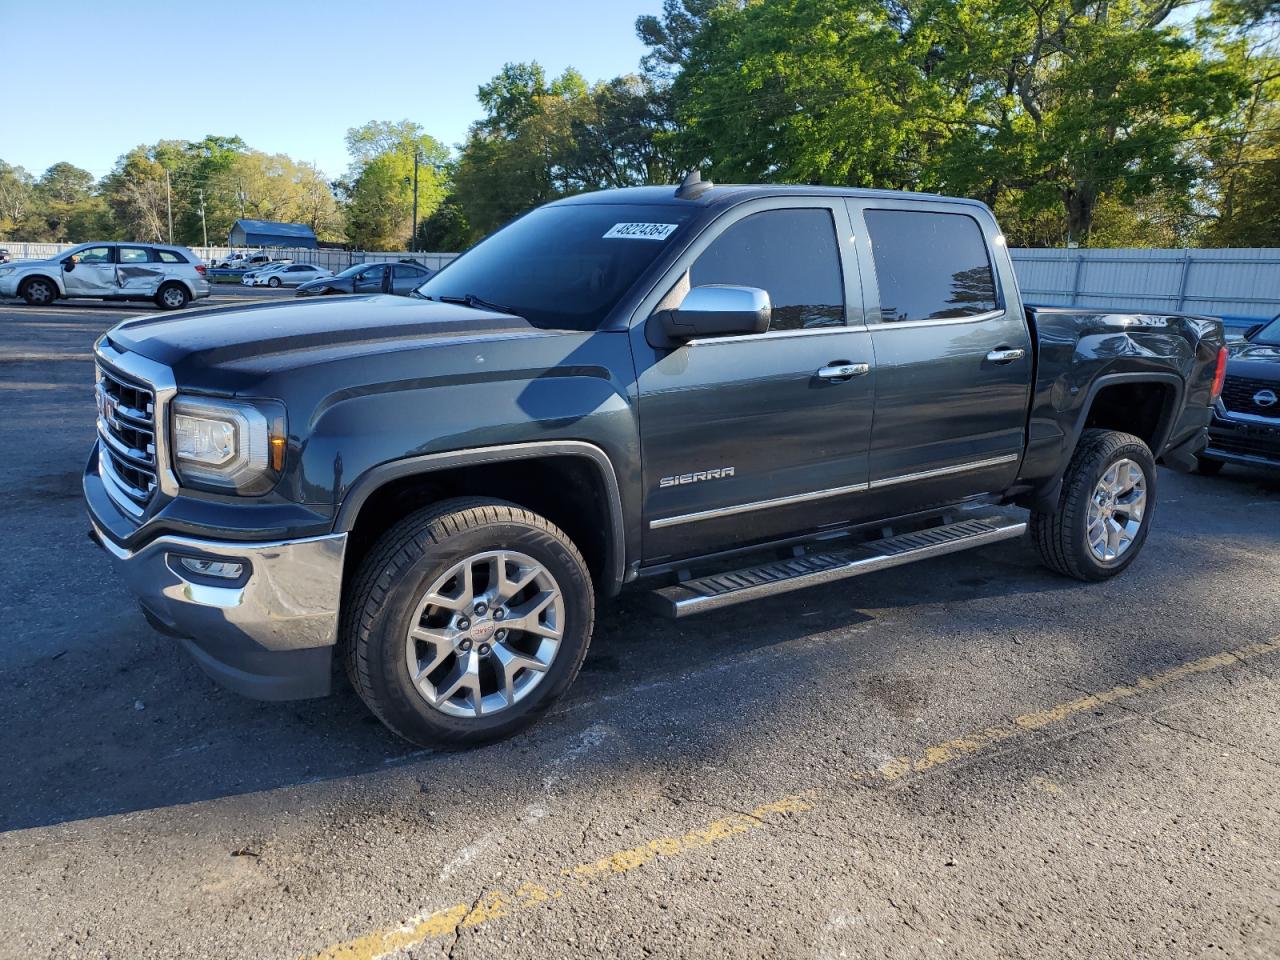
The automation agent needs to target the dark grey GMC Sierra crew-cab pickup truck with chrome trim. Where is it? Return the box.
[83,175,1226,746]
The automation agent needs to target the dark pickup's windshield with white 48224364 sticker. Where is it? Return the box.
[417,204,692,330]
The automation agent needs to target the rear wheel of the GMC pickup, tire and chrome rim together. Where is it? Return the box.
[1030,430,1156,580]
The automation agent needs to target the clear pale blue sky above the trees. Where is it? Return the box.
[0,0,662,177]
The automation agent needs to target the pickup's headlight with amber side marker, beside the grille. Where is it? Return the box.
[172,397,288,495]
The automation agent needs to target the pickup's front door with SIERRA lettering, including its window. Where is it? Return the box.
[632,197,876,563]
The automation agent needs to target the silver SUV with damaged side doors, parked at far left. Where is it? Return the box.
[0,242,209,310]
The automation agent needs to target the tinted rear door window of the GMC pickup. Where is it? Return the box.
[865,210,996,323]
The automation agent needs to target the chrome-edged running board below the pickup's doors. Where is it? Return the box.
[654,516,1027,620]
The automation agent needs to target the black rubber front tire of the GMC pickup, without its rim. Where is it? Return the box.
[342,498,595,749]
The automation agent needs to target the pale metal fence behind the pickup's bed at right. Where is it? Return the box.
[1010,248,1280,317]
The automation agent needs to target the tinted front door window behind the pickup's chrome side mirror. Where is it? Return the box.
[689,210,845,330]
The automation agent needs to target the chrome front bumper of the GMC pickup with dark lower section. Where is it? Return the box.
[91,515,347,700]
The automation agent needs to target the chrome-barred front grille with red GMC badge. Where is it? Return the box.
[96,364,156,515]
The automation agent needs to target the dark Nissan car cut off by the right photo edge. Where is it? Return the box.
[1198,316,1280,475]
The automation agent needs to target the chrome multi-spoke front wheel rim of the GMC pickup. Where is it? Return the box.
[406,550,564,718]
